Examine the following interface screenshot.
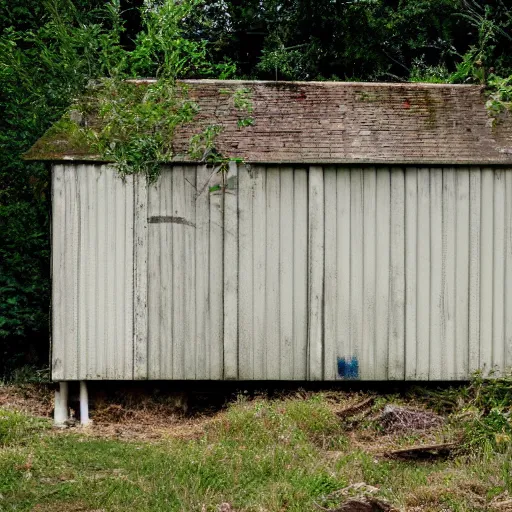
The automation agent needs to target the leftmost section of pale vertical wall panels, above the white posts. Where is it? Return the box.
[52,164,134,380]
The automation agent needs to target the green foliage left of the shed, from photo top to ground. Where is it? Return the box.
[0,0,132,375]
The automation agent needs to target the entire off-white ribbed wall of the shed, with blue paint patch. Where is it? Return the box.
[53,164,512,380]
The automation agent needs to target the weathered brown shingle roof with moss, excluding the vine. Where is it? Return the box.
[26,80,512,165]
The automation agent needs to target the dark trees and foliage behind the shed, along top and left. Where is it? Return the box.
[0,0,512,379]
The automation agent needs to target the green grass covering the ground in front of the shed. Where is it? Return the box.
[0,393,512,512]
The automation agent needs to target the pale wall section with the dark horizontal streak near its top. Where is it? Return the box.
[148,166,224,380]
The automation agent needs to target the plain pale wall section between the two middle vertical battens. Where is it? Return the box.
[238,166,308,379]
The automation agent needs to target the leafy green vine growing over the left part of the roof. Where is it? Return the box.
[48,0,246,181]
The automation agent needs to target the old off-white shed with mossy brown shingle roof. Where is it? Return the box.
[27,80,512,420]
